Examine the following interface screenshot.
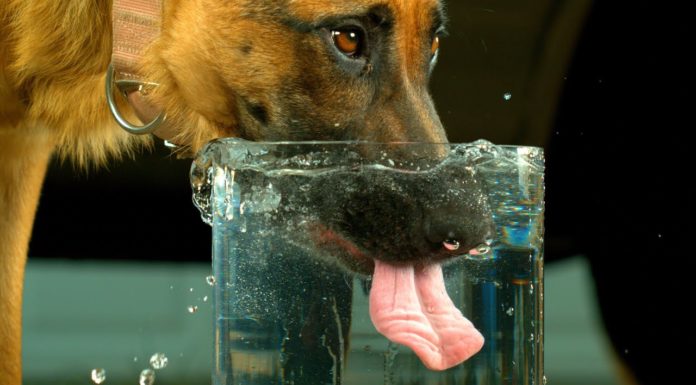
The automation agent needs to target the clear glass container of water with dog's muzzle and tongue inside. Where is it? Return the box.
[191,139,544,385]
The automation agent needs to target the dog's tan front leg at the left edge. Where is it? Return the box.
[0,129,53,385]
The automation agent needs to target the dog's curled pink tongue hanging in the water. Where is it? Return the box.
[370,260,483,370]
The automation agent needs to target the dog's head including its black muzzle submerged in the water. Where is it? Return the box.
[161,0,492,271]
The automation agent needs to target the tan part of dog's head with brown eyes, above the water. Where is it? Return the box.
[145,0,446,148]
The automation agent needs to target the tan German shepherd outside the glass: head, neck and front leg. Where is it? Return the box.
[0,0,489,385]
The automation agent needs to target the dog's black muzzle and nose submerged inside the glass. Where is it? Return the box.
[312,159,494,273]
